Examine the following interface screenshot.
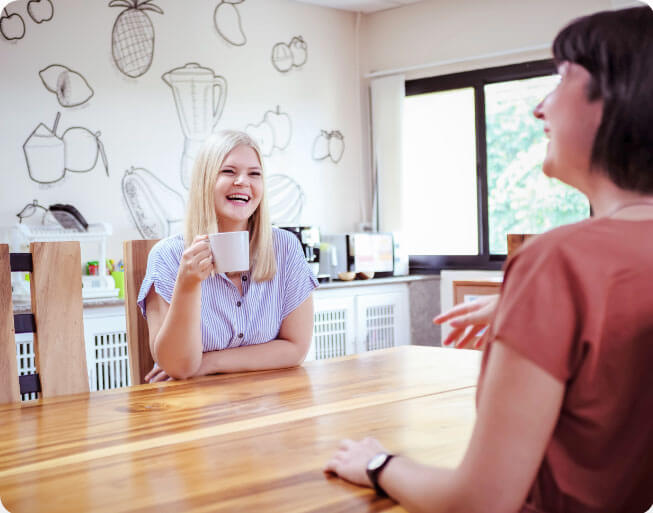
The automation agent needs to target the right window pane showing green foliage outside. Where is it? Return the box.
[484,75,589,254]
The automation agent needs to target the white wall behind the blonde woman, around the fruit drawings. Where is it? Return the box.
[0,0,366,259]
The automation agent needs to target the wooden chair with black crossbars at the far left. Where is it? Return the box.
[0,242,89,403]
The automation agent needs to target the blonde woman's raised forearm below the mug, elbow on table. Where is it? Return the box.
[153,282,203,379]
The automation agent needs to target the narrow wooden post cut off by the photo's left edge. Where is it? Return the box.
[0,244,20,404]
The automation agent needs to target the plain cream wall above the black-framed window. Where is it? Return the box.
[361,0,620,79]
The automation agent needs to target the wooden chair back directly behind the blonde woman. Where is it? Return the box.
[123,240,158,385]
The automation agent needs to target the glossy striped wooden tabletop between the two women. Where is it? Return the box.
[0,346,480,513]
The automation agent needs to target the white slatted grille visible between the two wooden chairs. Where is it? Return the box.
[89,331,131,392]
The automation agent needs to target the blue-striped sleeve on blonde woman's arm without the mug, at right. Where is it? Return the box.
[281,232,318,320]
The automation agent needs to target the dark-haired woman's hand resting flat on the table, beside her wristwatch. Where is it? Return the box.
[324,437,387,487]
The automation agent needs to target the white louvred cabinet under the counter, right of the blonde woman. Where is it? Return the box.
[306,283,410,360]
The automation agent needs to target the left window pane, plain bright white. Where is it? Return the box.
[402,87,479,255]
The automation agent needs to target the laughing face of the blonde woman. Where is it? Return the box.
[213,145,263,232]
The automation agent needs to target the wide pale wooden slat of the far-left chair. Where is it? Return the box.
[30,242,89,397]
